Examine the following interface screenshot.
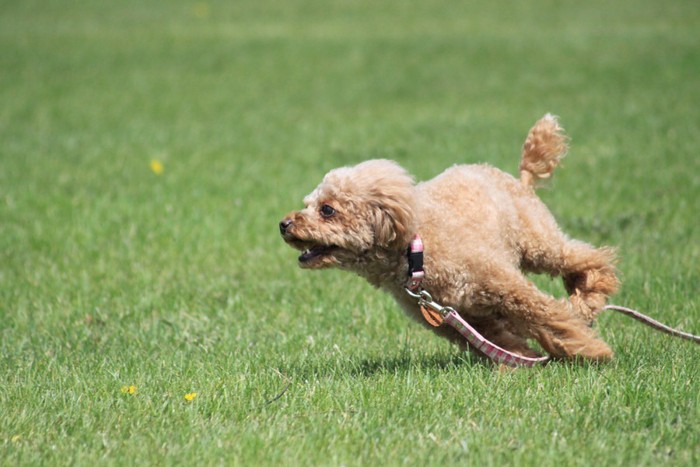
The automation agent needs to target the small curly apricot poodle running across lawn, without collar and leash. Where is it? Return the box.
[280,114,619,360]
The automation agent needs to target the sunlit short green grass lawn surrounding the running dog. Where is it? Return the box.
[0,0,700,466]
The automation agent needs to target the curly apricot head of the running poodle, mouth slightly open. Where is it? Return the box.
[279,160,415,269]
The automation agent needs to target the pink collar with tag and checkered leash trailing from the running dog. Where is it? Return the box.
[406,235,700,367]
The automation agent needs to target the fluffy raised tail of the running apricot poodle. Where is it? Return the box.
[520,114,568,187]
